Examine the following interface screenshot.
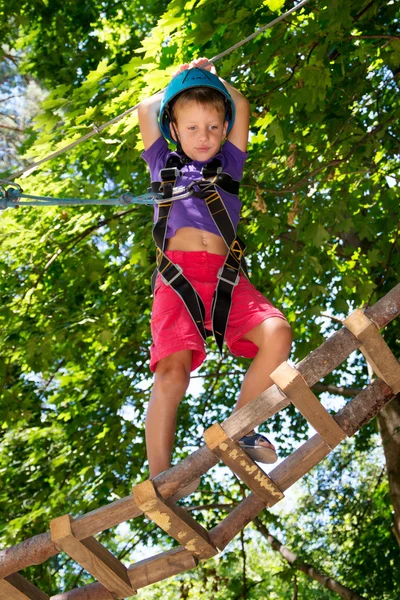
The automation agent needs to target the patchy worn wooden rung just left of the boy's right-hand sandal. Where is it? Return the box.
[204,423,283,506]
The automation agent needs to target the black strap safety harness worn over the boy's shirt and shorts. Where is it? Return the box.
[151,154,248,353]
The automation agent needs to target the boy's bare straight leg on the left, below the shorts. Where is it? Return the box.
[146,350,192,479]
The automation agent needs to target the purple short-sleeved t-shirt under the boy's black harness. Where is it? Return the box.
[142,137,247,238]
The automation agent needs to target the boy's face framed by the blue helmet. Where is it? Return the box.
[170,101,228,162]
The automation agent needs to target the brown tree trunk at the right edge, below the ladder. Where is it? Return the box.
[377,394,400,546]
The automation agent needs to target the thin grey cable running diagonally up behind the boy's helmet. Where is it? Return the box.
[8,0,310,180]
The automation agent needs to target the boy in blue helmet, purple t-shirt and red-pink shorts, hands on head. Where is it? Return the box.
[139,59,291,500]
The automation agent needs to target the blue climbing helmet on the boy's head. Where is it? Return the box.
[158,67,235,144]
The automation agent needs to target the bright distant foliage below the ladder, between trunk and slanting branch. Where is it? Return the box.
[258,434,399,600]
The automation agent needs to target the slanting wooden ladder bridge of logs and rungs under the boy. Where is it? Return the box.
[0,284,400,600]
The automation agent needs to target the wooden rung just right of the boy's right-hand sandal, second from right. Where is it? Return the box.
[270,362,346,448]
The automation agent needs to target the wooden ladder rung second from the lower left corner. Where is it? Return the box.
[50,515,136,598]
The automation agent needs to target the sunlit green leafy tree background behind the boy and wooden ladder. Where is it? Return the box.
[0,0,400,600]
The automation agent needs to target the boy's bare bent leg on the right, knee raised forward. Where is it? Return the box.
[234,317,292,447]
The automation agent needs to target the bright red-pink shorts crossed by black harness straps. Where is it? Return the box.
[150,251,285,373]
